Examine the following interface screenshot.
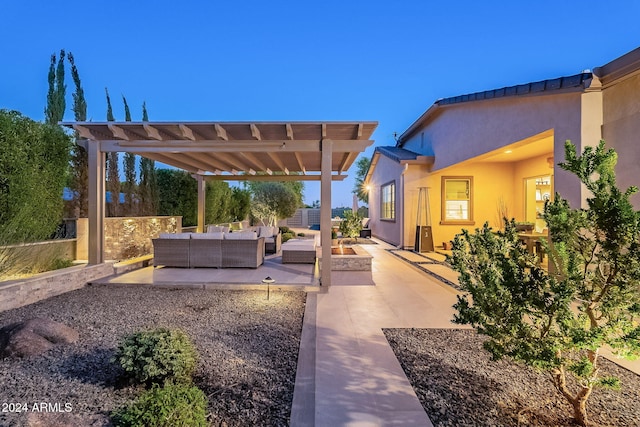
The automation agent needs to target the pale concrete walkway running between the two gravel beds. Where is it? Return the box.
[291,244,464,427]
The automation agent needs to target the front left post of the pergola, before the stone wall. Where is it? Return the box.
[86,141,105,264]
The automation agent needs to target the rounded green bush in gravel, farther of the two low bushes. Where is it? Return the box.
[113,328,197,385]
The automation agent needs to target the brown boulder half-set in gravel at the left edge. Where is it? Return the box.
[0,318,79,357]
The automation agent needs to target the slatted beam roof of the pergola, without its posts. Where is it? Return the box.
[63,121,378,181]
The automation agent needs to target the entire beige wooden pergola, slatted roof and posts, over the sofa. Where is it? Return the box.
[62,122,378,285]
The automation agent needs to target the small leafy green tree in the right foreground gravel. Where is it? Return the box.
[450,142,640,426]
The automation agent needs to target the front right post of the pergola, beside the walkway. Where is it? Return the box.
[320,139,333,286]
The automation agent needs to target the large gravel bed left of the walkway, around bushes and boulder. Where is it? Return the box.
[0,286,305,426]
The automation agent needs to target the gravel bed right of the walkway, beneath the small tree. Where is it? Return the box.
[384,329,640,427]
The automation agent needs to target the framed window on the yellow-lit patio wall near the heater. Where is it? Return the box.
[441,176,473,224]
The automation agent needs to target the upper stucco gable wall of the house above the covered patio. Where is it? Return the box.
[404,92,588,206]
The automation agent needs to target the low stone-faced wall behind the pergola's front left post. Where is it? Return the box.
[76,216,182,260]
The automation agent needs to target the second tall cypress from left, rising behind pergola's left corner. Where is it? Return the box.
[68,52,89,217]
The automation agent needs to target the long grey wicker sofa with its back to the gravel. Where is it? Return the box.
[153,231,265,268]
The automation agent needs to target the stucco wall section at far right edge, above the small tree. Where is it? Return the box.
[603,74,640,209]
